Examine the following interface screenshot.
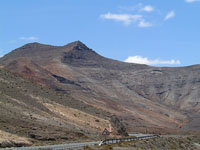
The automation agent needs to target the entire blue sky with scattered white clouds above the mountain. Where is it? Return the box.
[0,0,200,67]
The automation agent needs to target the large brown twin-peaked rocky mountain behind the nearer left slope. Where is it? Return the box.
[0,41,200,145]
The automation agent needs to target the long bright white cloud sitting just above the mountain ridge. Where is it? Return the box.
[125,56,181,65]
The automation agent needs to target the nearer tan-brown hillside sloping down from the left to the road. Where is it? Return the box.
[0,69,126,147]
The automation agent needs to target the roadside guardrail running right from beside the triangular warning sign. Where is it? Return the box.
[99,135,160,145]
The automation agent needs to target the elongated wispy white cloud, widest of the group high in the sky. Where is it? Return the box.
[100,13,143,25]
